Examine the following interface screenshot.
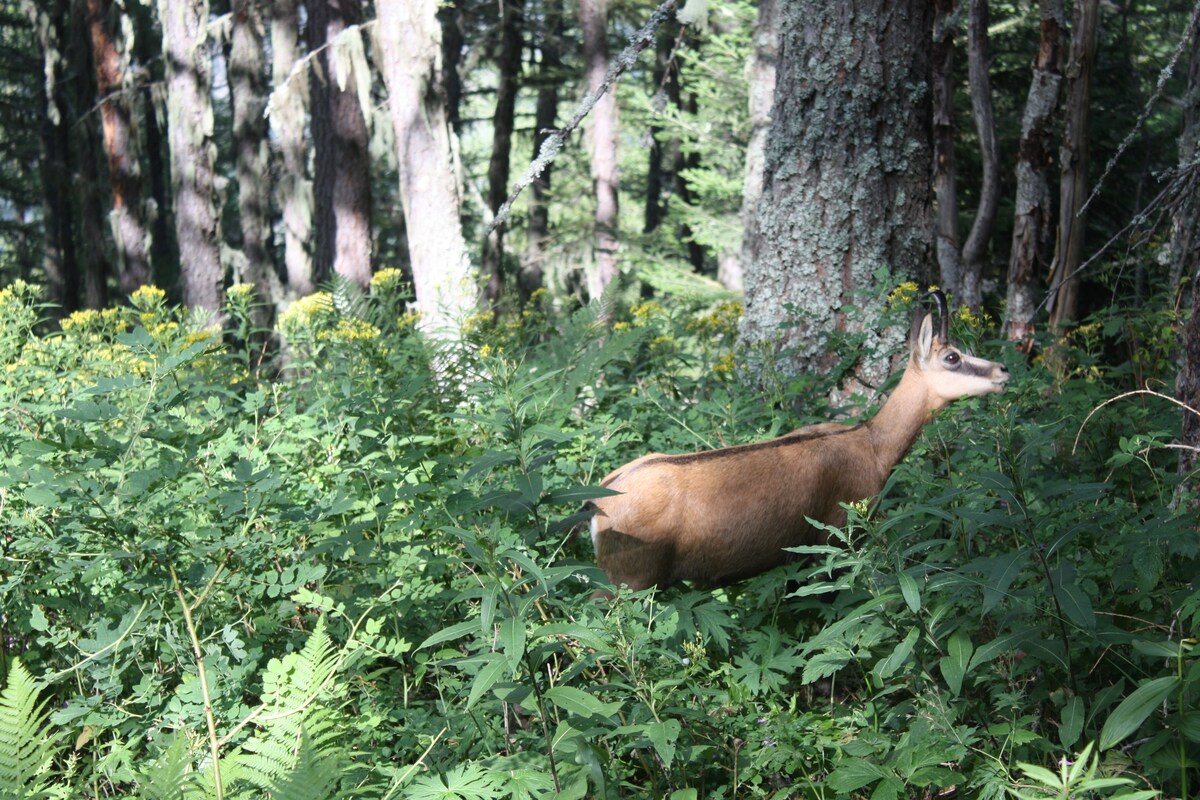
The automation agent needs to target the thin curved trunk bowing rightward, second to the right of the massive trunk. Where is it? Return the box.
[960,0,1000,309]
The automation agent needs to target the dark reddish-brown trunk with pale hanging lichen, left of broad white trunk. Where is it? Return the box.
[307,0,369,288]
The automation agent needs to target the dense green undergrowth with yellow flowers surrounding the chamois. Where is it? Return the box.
[0,278,1200,800]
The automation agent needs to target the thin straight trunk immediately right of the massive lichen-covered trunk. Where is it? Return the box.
[930,0,962,303]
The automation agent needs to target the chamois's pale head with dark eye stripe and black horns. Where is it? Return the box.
[908,289,1008,410]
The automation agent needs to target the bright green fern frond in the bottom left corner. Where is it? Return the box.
[0,660,58,798]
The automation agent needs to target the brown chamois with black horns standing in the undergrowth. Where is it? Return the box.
[589,290,1008,590]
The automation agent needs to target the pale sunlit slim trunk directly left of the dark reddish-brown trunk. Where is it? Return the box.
[271,0,317,296]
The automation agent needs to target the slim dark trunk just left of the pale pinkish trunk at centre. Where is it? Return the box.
[517,0,563,303]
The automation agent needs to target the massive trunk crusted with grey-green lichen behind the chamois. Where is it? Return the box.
[742,0,934,385]
